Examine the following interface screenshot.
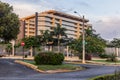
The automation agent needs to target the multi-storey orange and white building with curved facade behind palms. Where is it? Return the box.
[18,10,91,39]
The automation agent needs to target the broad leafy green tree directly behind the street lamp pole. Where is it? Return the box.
[70,29,106,57]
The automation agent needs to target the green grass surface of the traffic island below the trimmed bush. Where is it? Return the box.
[24,60,85,71]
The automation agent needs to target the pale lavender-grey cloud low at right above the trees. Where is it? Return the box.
[93,16,120,40]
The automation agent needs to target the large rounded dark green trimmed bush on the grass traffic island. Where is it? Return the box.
[34,52,64,65]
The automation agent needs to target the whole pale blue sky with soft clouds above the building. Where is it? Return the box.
[0,0,120,40]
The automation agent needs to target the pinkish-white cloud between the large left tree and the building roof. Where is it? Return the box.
[13,0,54,17]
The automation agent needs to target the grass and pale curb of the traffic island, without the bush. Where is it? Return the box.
[16,60,85,73]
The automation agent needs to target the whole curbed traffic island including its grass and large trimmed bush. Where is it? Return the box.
[17,52,85,73]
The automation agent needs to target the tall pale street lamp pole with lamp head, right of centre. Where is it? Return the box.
[74,11,85,63]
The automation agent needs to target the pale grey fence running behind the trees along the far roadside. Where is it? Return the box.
[0,44,120,57]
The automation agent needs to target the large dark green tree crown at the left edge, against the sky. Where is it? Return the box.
[0,1,19,42]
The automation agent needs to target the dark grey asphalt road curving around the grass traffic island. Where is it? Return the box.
[0,59,120,80]
